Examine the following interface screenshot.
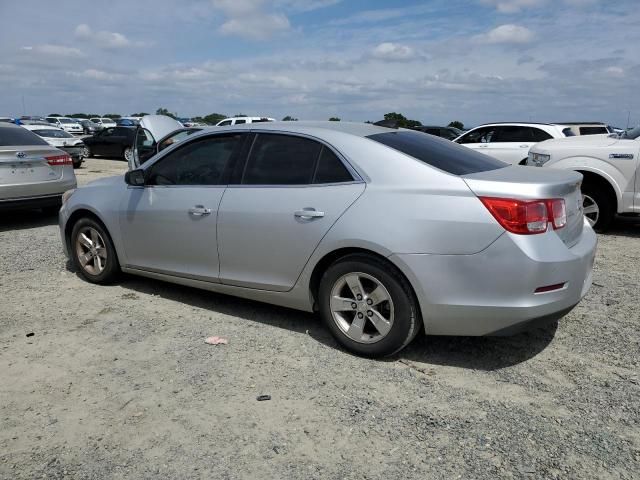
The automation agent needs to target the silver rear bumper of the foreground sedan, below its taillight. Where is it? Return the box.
[390,220,597,336]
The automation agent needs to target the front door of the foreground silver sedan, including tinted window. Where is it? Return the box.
[120,133,246,282]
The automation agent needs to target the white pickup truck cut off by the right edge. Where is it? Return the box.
[527,126,640,231]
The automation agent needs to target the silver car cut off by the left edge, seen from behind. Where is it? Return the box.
[0,123,76,211]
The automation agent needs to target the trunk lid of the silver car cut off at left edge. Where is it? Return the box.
[0,145,66,185]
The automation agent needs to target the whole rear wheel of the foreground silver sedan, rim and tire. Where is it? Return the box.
[318,254,419,357]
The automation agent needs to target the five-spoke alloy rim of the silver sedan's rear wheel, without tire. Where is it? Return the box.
[330,272,394,343]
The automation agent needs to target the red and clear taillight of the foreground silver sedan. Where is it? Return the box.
[480,197,567,235]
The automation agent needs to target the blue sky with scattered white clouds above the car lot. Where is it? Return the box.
[0,0,640,127]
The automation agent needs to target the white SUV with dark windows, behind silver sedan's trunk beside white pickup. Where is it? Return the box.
[454,123,573,165]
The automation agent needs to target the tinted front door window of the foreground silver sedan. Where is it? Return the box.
[147,134,242,186]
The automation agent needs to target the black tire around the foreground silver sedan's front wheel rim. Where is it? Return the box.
[69,217,120,284]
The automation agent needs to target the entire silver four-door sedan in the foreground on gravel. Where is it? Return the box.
[60,122,596,356]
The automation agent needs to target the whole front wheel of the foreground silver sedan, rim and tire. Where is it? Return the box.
[70,217,120,283]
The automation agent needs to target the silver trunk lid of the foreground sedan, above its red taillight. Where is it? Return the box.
[461,165,584,247]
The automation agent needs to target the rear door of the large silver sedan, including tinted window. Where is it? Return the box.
[218,132,365,291]
